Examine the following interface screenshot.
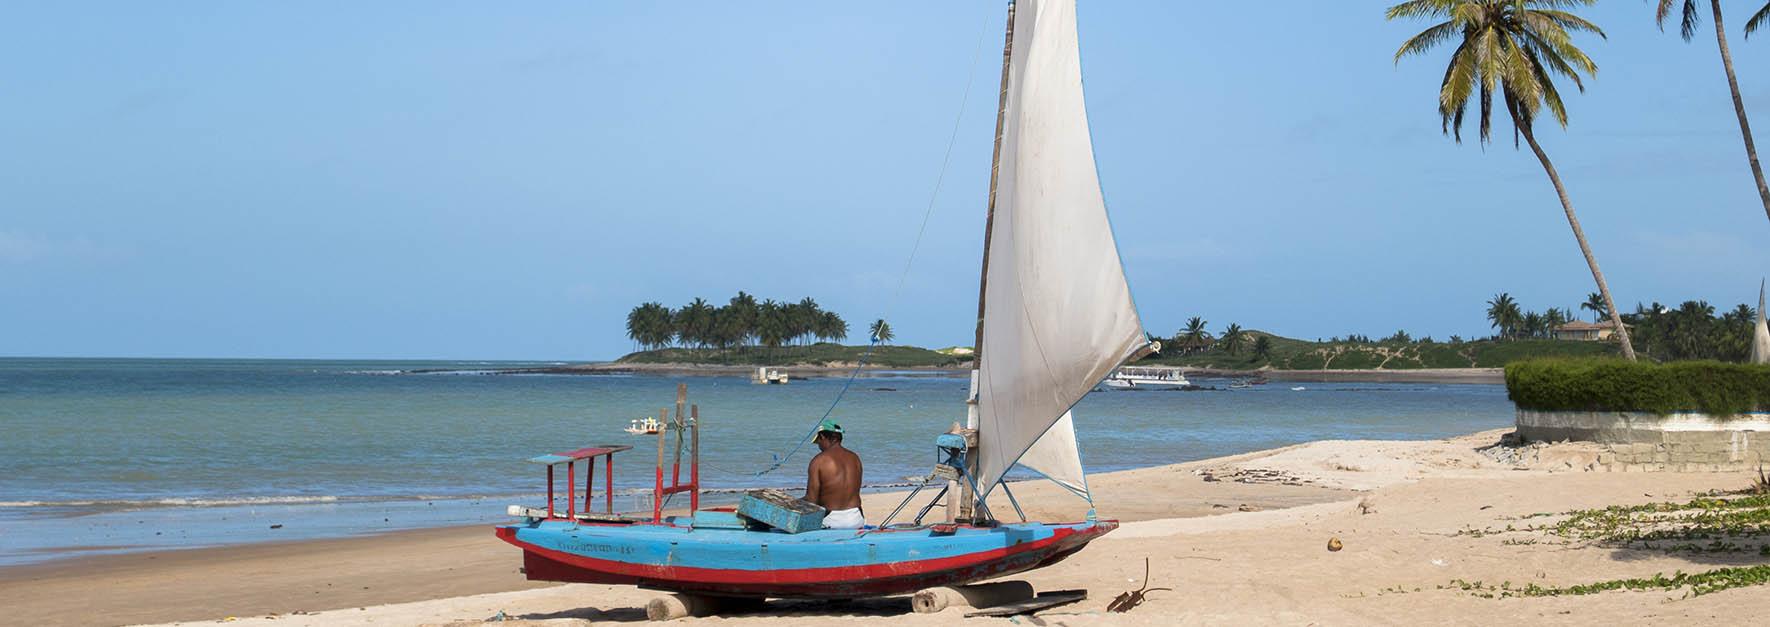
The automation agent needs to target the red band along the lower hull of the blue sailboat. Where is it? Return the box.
[497,523,1117,599]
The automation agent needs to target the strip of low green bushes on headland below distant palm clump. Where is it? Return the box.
[620,342,972,368]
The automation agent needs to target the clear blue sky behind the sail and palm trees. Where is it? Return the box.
[0,0,1770,360]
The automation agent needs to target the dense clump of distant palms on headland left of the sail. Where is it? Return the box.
[627,292,870,349]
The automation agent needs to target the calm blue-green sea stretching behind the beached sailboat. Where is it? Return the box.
[0,358,1512,565]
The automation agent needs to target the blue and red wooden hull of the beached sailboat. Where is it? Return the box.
[497,521,1119,599]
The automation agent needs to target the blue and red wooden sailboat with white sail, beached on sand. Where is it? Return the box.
[497,0,1156,599]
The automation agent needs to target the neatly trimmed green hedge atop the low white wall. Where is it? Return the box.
[1506,360,1770,418]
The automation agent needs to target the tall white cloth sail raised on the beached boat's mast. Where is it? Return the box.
[977,0,1145,498]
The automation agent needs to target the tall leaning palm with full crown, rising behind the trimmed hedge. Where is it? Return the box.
[1386,0,1635,360]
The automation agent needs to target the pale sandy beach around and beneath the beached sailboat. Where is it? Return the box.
[0,430,1770,625]
